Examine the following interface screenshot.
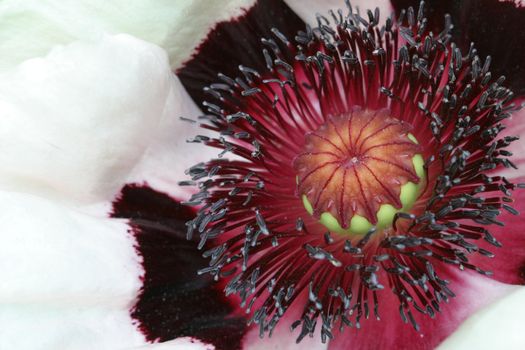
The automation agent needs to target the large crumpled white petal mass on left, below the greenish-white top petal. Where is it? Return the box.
[0,35,201,350]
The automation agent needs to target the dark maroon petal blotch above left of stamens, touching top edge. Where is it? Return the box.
[177,0,305,102]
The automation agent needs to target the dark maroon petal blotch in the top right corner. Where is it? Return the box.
[392,0,525,94]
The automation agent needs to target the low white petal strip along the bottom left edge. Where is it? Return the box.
[0,304,145,350]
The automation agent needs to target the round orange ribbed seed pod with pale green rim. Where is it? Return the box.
[294,109,425,234]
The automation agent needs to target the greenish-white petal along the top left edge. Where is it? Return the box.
[0,0,254,71]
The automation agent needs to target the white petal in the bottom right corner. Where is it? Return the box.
[439,287,525,350]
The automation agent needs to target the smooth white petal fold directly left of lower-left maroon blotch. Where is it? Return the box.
[0,191,142,307]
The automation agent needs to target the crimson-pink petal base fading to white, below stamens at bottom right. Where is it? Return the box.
[328,270,515,350]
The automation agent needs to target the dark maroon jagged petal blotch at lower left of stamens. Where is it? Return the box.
[112,185,246,350]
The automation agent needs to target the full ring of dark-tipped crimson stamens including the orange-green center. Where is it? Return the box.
[183,3,525,341]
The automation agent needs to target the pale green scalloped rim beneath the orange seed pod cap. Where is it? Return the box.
[302,134,426,235]
